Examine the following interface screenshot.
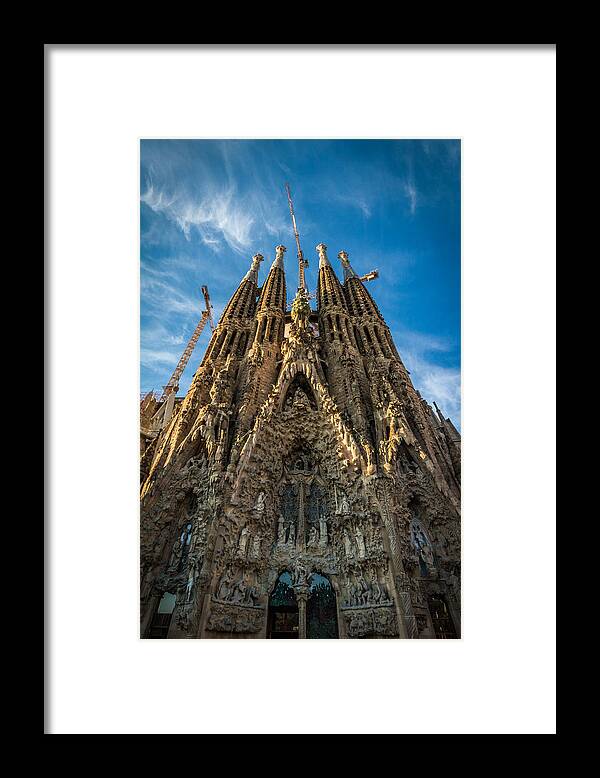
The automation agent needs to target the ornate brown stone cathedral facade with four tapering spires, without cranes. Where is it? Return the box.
[140,244,460,639]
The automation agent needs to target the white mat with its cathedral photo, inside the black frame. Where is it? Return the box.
[44,44,556,735]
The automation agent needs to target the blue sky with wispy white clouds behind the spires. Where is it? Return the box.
[140,140,460,428]
